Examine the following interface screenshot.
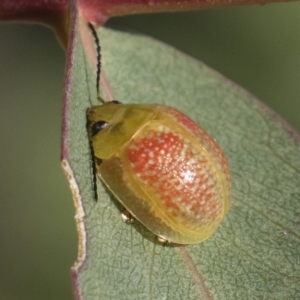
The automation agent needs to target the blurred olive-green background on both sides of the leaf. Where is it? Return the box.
[0,2,300,300]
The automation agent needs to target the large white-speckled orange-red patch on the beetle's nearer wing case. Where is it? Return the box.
[127,126,222,224]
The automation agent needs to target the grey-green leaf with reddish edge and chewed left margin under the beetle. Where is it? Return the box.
[62,15,300,299]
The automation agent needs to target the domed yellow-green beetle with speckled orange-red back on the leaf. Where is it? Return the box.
[87,24,231,244]
